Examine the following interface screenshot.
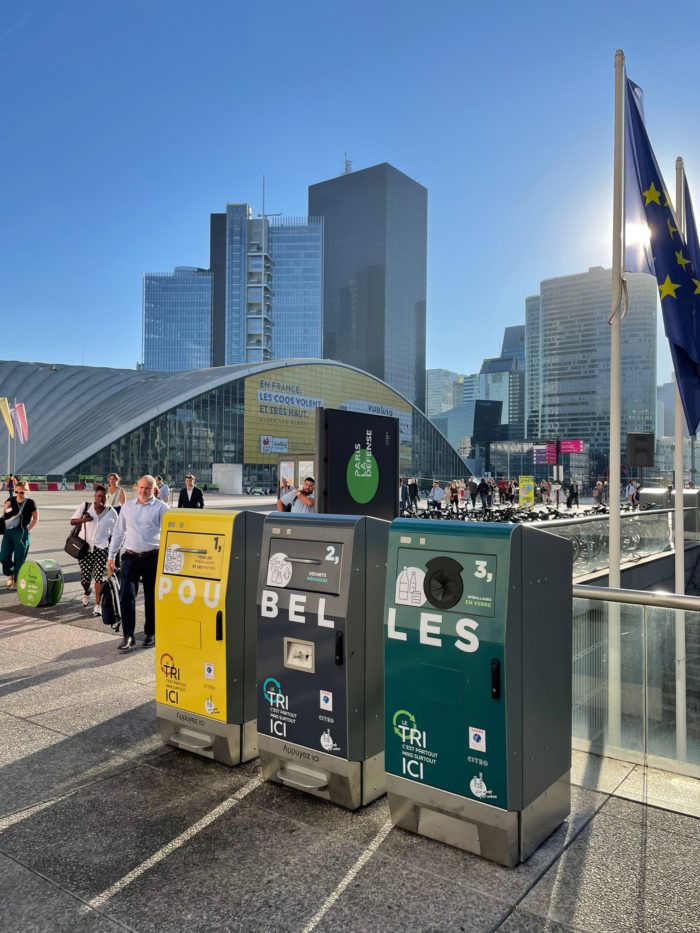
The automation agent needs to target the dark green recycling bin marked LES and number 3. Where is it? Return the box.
[384,519,572,865]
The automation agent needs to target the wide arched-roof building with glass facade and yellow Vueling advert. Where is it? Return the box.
[0,359,466,491]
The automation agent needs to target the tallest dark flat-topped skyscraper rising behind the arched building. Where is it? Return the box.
[309,162,428,410]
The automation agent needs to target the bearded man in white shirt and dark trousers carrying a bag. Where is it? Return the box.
[107,473,168,651]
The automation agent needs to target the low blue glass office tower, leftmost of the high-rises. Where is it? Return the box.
[142,266,212,372]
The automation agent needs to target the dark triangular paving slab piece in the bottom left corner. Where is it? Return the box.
[0,855,124,933]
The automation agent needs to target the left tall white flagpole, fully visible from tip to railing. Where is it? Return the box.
[607,49,625,746]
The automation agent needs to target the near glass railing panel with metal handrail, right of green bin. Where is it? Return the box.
[572,585,700,777]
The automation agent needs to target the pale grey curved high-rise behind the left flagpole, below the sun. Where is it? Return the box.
[525,266,658,460]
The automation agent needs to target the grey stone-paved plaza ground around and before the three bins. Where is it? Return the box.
[0,493,700,933]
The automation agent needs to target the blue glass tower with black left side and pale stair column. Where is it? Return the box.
[210,204,323,366]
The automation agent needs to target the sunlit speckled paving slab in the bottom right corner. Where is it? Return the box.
[520,810,698,933]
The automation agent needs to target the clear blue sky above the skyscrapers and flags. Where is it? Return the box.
[0,0,700,381]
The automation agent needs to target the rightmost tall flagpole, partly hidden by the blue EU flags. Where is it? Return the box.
[673,156,688,761]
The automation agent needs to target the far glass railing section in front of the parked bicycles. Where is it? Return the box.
[541,509,673,579]
